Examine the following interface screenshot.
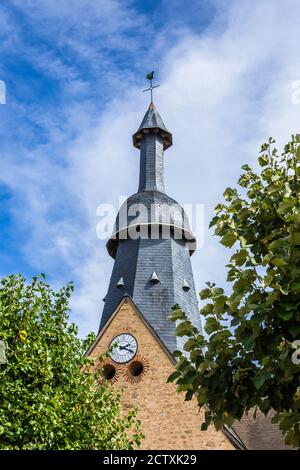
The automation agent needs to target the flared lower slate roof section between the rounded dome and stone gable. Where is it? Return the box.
[100,237,201,353]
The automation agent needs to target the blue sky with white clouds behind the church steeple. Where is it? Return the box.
[0,0,300,336]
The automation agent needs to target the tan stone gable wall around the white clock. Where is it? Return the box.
[89,299,234,450]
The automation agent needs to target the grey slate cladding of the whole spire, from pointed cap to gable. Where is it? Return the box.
[100,105,201,352]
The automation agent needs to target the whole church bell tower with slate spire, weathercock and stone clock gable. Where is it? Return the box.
[87,77,238,450]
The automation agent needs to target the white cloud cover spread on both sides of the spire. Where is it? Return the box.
[2,0,300,334]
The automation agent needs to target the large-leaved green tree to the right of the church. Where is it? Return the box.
[169,135,300,447]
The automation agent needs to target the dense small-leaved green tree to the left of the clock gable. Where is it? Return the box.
[0,275,141,450]
